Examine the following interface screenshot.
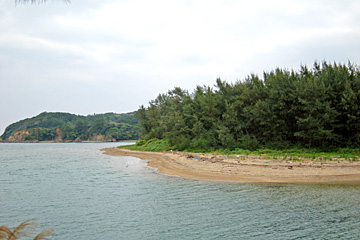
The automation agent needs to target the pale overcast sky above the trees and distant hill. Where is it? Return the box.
[0,0,360,135]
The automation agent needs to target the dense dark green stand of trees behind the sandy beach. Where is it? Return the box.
[137,62,360,151]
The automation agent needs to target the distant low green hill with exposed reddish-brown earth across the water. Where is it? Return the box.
[1,112,140,141]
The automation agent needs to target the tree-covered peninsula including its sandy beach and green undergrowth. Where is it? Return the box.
[101,61,360,183]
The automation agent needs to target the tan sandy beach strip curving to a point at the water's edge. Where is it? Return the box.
[102,148,360,184]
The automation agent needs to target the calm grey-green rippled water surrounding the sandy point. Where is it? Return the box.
[0,143,360,240]
